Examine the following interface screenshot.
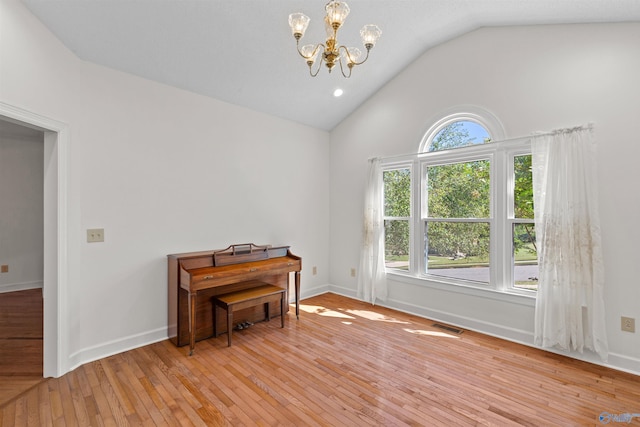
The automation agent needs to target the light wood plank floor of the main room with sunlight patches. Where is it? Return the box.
[0,294,640,426]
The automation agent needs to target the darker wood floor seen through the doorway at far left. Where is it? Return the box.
[0,289,43,406]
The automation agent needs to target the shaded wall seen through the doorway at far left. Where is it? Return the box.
[0,129,44,292]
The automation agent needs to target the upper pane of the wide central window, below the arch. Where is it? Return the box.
[426,160,491,218]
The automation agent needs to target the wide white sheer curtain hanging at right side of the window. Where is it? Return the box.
[531,126,608,360]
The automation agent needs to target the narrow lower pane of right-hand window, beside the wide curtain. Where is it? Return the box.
[513,223,538,291]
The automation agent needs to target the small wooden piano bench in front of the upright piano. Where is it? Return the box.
[212,283,286,347]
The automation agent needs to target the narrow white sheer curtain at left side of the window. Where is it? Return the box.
[358,158,387,304]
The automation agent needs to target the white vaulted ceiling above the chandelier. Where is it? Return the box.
[23,0,640,130]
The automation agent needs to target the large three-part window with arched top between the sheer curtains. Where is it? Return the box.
[382,116,537,293]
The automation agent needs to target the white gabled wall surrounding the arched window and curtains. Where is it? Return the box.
[330,23,640,372]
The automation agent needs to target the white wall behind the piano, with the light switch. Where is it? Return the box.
[0,0,329,374]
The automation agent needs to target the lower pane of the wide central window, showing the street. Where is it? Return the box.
[425,221,490,283]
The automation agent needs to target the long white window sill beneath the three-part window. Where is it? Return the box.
[386,270,536,307]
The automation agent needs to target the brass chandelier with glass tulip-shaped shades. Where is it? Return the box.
[289,0,382,78]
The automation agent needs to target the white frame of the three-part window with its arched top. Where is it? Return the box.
[381,106,536,305]
